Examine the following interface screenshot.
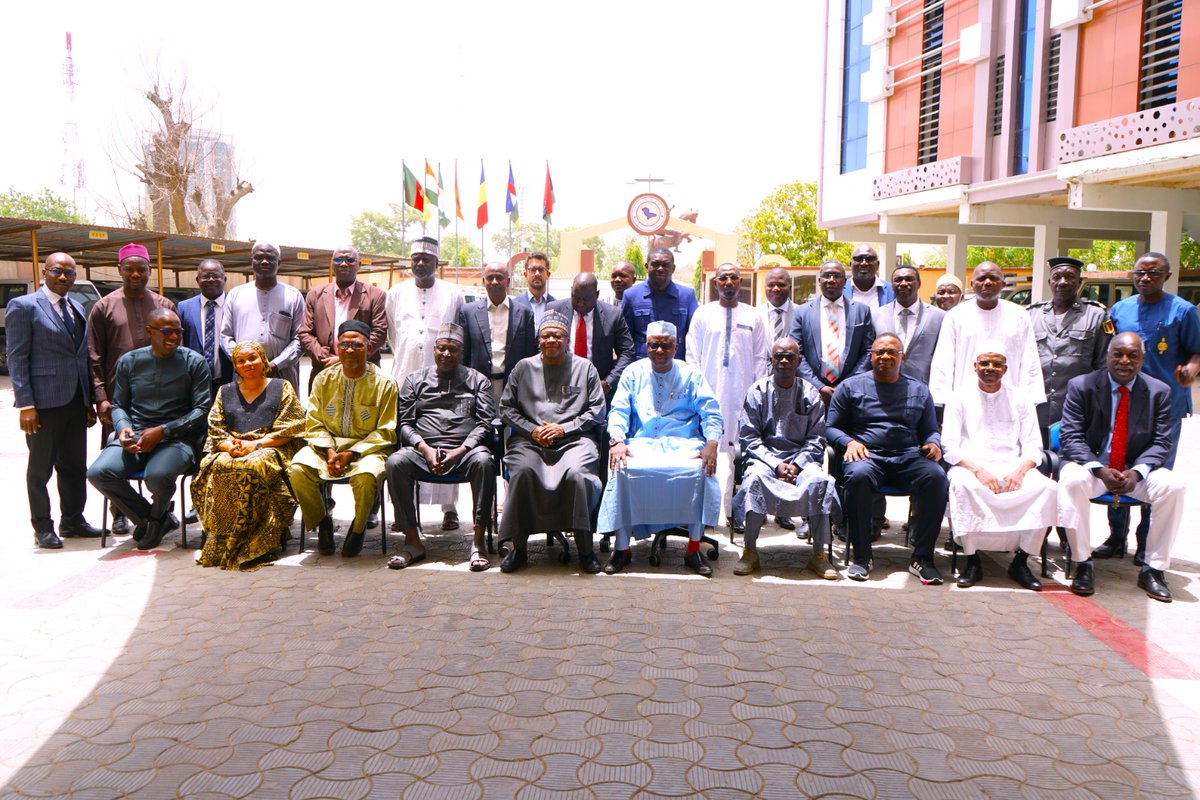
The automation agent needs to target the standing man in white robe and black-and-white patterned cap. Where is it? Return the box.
[386,236,462,530]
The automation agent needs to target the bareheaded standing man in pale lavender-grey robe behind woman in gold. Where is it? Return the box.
[221,242,304,395]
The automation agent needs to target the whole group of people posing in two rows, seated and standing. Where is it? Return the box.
[7,237,1200,600]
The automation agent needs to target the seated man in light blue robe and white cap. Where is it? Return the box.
[596,321,725,577]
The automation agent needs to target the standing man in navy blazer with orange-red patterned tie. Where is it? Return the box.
[792,260,875,405]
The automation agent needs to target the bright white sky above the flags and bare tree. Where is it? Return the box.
[0,0,823,260]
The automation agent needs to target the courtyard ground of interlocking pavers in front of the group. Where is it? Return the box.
[0,371,1200,799]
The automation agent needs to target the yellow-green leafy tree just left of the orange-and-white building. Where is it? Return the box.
[737,181,853,266]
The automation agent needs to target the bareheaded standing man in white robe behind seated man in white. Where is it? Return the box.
[929,261,1046,405]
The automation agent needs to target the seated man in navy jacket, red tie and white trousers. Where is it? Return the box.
[1058,331,1183,602]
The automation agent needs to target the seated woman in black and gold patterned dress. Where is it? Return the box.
[192,341,304,570]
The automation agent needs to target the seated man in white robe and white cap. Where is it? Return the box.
[942,342,1058,591]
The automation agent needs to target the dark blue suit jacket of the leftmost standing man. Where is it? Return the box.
[5,287,92,409]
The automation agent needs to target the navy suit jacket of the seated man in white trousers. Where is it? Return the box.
[1058,369,1171,469]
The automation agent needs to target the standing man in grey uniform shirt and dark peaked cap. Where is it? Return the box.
[1030,255,1109,445]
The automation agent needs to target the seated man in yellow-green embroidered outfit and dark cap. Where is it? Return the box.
[288,319,397,558]
